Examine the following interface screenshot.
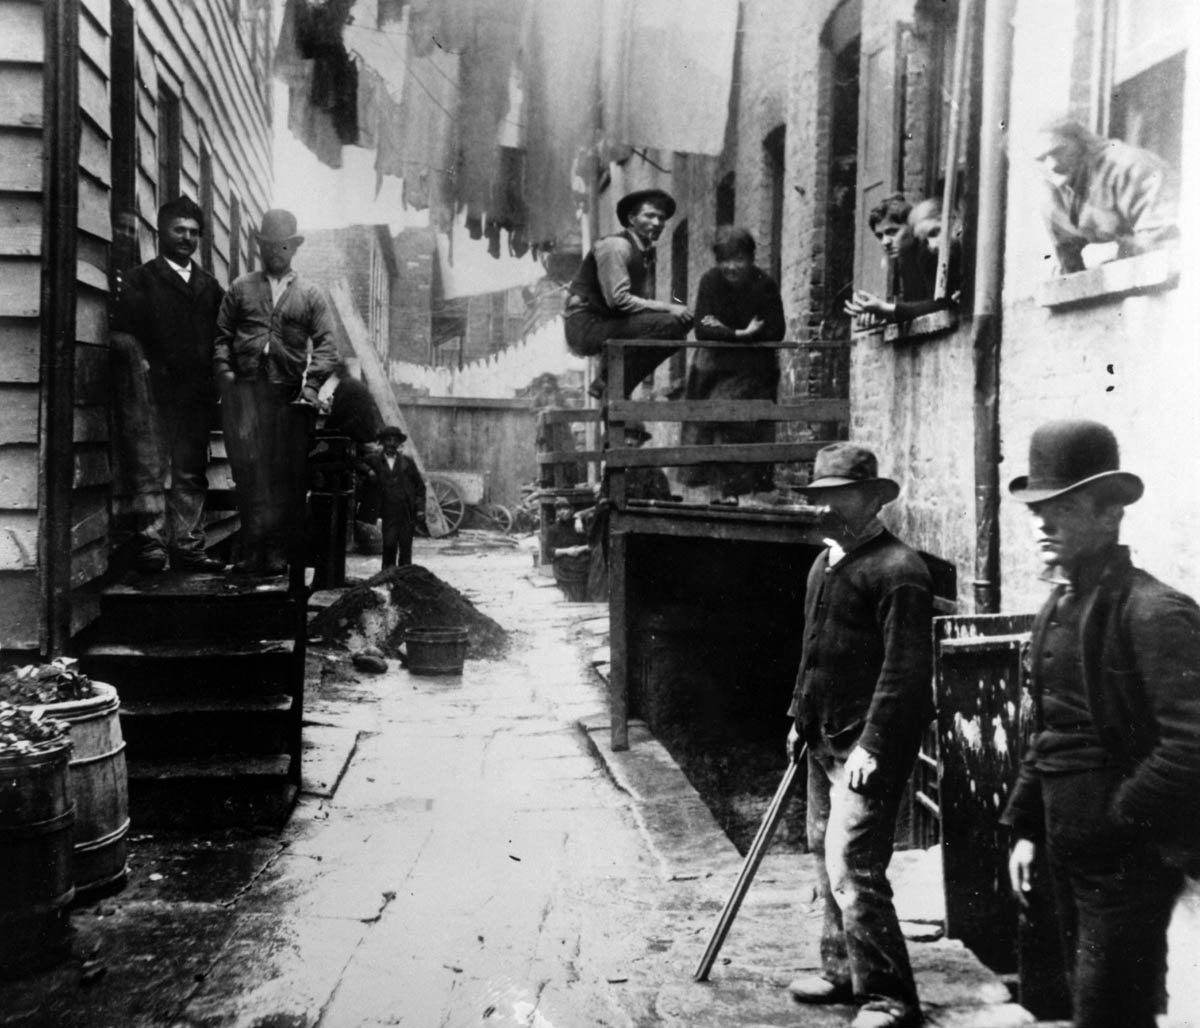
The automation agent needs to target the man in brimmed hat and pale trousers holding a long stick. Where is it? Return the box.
[787,443,934,1028]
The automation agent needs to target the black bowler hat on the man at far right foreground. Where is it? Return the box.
[1008,420,1145,504]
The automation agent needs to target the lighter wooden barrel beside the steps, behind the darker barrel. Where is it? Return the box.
[38,681,130,897]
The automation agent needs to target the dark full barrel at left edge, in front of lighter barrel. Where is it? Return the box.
[0,738,74,978]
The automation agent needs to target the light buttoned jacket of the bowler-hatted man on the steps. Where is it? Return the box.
[214,271,337,393]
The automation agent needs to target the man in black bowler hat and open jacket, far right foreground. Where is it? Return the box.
[1001,421,1200,1028]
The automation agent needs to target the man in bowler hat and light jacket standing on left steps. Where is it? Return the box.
[214,210,337,575]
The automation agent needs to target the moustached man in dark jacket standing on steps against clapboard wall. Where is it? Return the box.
[113,197,224,572]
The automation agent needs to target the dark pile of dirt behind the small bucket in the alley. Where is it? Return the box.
[308,564,509,660]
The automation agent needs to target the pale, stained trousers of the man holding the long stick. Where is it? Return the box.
[806,744,918,1011]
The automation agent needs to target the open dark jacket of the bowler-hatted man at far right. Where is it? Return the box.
[1001,546,1200,855]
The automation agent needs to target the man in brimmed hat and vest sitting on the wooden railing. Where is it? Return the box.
[564,190,691,398]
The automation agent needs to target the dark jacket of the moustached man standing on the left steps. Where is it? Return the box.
[112,257,224,403]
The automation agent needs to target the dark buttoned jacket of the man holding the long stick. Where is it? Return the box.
[788,529,934,777]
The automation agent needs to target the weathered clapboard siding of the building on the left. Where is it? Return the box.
[0,0,271,650]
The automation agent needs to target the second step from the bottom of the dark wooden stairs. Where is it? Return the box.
[120,693,300,761]
